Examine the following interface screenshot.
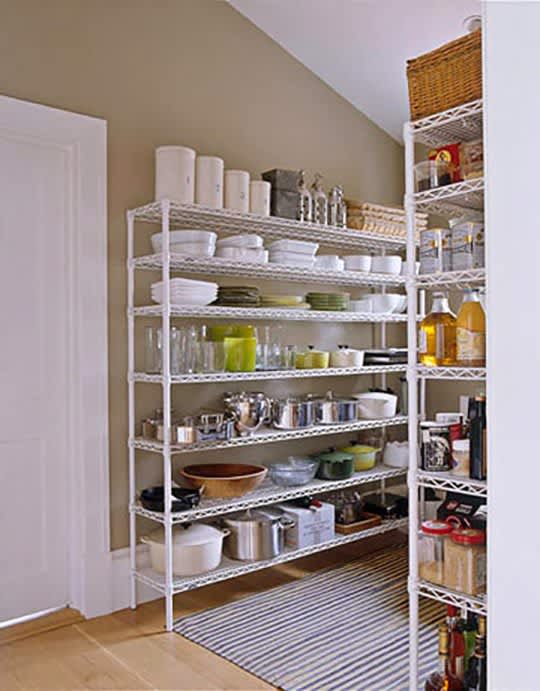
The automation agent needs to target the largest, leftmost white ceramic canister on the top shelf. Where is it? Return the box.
[155,146,195,204]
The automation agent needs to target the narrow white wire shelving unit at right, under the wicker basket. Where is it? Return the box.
[403,101,488,689]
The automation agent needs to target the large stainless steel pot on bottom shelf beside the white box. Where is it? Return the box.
[223,509,295,561]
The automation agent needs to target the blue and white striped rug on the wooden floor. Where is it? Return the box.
[175,547,444,691]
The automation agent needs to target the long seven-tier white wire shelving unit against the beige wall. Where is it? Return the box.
[127,200,407,631]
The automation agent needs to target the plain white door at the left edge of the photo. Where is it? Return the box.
[0,99,107,622]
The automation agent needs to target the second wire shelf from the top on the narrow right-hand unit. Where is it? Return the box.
[414,178,484,218]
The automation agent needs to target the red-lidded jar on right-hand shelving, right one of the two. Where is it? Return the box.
[444,528,486,595]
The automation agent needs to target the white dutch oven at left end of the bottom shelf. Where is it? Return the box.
[141,523,230,576]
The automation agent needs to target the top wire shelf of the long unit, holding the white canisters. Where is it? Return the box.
[130,201,406,250]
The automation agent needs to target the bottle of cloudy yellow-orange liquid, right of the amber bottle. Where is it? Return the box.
[456,289,486,367]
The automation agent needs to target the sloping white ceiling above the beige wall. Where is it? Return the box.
[230,0,481,141]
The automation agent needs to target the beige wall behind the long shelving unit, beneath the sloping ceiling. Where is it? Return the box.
[0,0,403,547]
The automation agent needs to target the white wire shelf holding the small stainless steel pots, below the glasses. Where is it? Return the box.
[129,415,407,454]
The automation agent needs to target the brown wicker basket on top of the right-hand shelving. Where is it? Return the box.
[407,29,482,120]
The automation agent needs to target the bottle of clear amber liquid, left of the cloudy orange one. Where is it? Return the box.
[418,293,456,367]
